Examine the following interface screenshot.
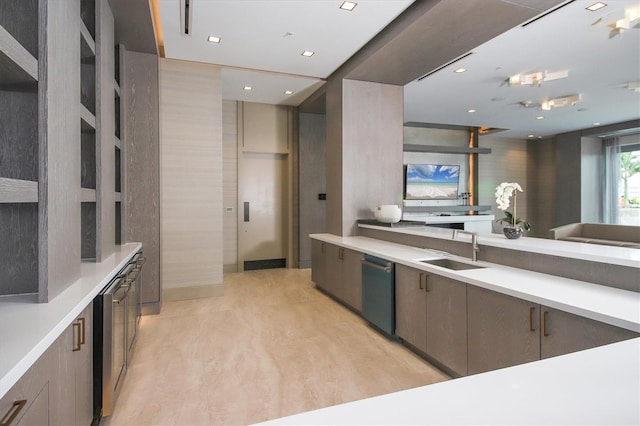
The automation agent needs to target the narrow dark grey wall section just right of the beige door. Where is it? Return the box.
[298,113,326,268]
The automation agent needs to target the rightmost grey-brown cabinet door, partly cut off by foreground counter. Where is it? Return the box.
[540,306,638,358]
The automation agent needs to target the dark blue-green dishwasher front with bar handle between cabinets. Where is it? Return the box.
[362,254,396,336]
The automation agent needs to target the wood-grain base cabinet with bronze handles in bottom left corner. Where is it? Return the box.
[0,304,93,426]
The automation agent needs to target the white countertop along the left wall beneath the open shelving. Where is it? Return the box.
[0,243,142,398]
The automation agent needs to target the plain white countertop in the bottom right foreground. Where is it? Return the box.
[264,338,640,425]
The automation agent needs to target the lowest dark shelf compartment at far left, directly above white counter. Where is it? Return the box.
[0,203,38,295]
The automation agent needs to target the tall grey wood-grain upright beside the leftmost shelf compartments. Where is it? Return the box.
[39,1,81,302]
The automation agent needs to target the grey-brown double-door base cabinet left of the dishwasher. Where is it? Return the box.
[311,240,362,312]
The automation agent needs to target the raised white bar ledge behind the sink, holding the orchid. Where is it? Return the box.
[358,224,640,268]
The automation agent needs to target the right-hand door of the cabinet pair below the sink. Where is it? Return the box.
[425,275,467,376]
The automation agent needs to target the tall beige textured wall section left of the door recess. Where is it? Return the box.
[160,59,223,301]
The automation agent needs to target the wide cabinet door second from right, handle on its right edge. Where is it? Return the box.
[467,286,540,374]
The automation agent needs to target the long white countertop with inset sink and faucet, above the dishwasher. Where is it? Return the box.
[311,235,640,332]
